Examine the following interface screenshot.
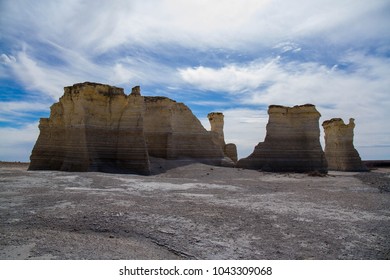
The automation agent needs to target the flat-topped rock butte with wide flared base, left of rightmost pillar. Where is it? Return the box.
[237,104,327,173]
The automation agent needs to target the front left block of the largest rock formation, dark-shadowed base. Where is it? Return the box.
[29,82,150,174]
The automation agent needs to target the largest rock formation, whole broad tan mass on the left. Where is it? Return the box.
[29,82,229,174]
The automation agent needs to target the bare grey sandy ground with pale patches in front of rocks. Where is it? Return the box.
[0,163,390,259]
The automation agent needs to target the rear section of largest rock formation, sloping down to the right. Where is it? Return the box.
[144,97,224,162]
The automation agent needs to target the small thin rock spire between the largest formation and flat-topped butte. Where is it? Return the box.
[207,112,237,163]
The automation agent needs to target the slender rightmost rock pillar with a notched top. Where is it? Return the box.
[322,118,367,171]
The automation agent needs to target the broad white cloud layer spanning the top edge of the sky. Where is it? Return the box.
[2,0,389,52]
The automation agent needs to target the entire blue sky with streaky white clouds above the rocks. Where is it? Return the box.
[0,0,390,161]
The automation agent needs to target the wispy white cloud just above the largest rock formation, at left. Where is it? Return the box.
[3,47,179,101]
